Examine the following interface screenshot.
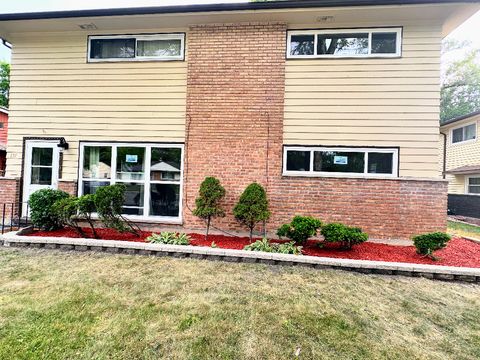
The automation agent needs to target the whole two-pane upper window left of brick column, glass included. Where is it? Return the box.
[88,34,185,62]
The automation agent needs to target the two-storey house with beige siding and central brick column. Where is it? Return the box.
[0,0,479,239]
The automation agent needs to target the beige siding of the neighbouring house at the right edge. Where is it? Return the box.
[442,115,480,194]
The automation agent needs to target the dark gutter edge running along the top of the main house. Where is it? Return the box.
[0,0,478,21]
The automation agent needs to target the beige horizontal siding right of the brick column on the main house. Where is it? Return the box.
[284,24,442,177]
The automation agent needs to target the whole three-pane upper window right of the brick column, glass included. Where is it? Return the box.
[287,28,402,59]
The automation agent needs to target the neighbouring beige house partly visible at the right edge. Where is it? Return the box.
[440,111,480,218]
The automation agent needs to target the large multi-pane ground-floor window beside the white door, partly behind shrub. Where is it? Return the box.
[79,143,183,220]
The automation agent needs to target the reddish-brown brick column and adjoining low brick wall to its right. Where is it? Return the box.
[184,23,447,239]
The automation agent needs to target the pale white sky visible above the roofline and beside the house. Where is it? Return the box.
[0,0,480,61]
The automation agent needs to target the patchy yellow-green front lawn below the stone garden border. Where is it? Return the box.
[0,248,480,360]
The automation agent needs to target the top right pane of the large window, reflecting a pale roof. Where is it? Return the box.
[150,148,182,181]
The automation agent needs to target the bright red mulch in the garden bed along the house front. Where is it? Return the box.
[26,229,480,267]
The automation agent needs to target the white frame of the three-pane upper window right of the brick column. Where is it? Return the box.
[287,27,402,59]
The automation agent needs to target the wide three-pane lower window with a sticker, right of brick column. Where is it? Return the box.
[283,146,398,177]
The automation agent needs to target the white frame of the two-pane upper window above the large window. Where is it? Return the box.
[87,33,185,63]
